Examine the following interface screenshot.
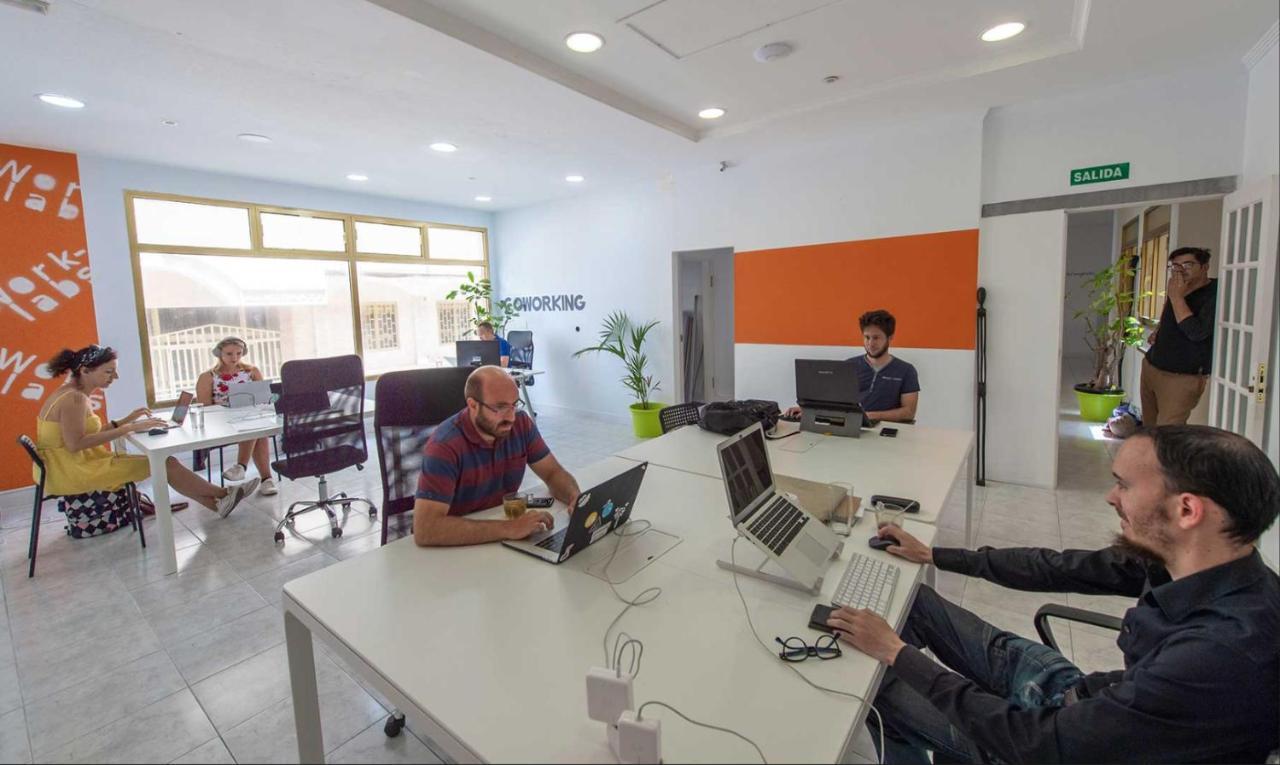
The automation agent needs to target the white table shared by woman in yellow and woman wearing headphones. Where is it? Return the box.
[127,399,374,574]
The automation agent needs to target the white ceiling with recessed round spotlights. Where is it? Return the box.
[0,0,1277,210]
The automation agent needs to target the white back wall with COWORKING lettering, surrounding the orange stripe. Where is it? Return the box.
[495,113,982,429]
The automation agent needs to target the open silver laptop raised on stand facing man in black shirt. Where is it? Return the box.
[716,423,840,587]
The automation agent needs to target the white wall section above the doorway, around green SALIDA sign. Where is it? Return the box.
[982,64,1244,202]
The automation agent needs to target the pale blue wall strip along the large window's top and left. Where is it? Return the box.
[79,155,495,411]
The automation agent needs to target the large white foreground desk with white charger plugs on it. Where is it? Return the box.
[283,458,933,762]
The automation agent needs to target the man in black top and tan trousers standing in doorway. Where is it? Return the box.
[1140,247,1217,426]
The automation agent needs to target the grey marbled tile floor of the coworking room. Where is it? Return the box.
[0,394,1125,762]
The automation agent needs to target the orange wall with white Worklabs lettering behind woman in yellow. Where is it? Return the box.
[0,143,104,490]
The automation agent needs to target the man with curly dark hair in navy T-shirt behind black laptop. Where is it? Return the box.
[785,310,920,422]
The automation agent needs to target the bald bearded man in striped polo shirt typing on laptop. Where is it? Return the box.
[413,366,580,548]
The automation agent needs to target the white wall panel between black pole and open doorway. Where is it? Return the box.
[978,210,1066,489]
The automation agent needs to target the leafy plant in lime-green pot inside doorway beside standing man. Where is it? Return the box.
[1075,260,1143,422]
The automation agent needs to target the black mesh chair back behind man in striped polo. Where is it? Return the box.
[374,367,472,545]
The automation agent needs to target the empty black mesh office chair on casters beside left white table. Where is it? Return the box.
[271,356,378,542]
